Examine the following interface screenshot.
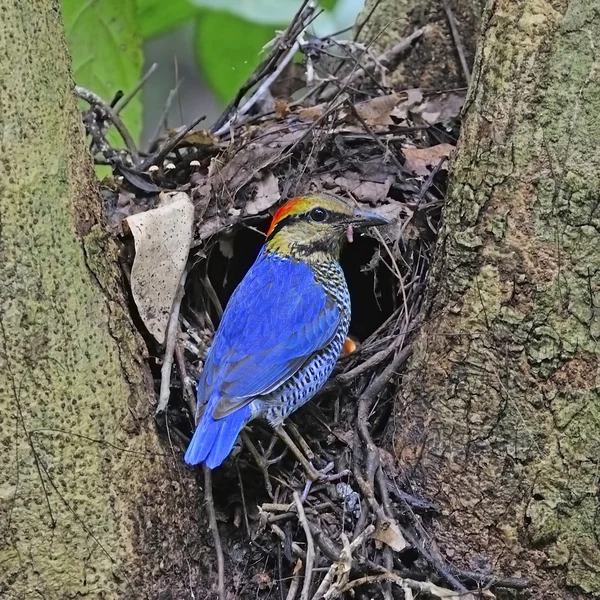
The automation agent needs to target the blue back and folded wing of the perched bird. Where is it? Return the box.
[198,255,341,419]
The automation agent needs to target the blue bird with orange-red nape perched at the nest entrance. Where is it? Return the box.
[184,193,388,469]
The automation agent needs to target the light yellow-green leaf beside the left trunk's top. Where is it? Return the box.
[62,0,143,141]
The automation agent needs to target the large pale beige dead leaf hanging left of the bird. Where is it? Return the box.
[127,192,194,344]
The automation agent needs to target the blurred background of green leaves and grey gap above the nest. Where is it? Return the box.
[62,0,364,148]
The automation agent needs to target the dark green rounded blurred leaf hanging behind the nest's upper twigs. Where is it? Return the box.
[195,11,283,103]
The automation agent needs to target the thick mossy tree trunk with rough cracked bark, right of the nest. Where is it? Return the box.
[394,0,600,600]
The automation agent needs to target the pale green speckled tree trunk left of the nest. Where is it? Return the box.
[0,0,206,600]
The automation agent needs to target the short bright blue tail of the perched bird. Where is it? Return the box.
[184,404,252,469]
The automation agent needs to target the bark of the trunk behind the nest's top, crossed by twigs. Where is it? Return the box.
[357,0,485,91]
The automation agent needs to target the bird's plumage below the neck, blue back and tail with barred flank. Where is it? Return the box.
[185,249,349,468]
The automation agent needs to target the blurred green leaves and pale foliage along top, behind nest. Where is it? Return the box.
[61,0,362,144]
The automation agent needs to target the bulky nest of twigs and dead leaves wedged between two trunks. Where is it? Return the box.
[78,3,520,600]
